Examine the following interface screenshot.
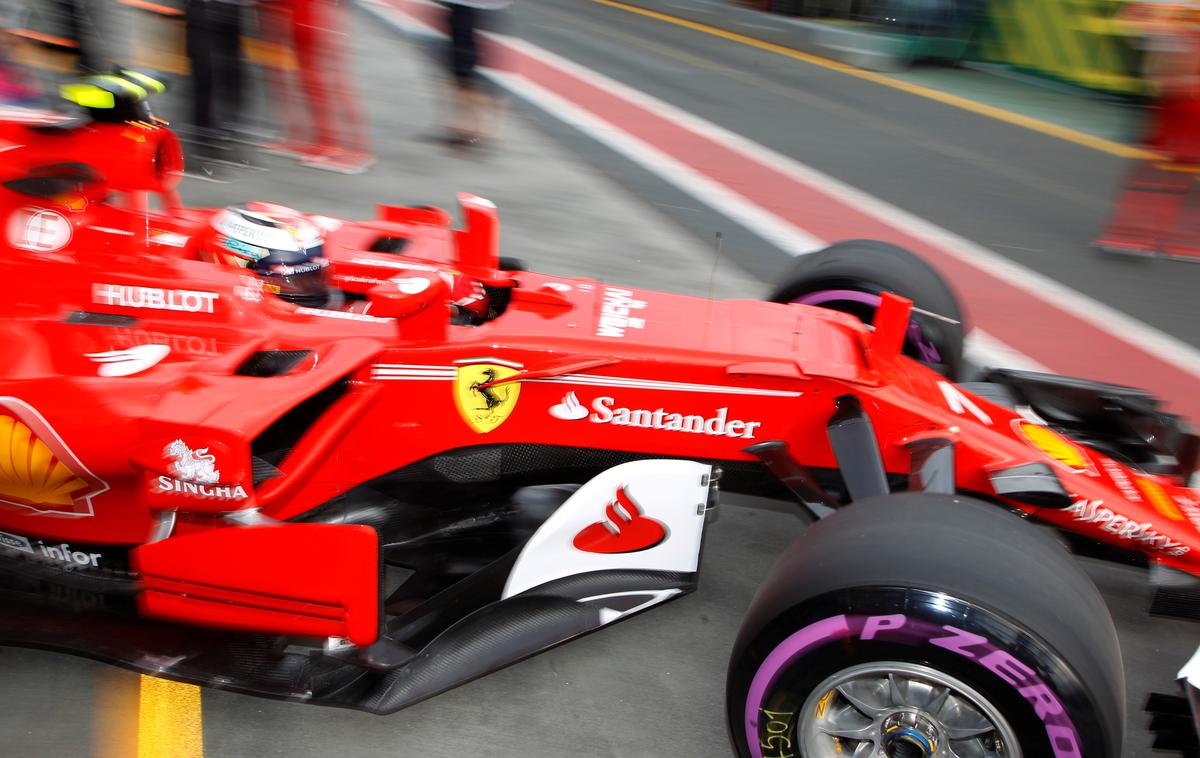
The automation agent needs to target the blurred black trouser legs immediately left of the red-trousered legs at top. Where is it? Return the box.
[185,0,244,166]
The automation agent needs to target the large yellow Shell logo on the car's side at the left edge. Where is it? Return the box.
[0,397,108,516]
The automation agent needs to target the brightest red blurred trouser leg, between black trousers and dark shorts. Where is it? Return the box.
[290,0,374,174]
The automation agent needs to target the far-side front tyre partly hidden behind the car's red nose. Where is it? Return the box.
[768,240,966,379]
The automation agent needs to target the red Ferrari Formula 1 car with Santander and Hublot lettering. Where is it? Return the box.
[0,75,1200,758]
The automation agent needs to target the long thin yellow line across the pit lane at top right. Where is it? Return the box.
[592,0,1158,160]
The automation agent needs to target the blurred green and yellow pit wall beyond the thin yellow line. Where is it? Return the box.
[662,0,1148,96]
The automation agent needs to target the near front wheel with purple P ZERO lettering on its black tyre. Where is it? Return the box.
[726,493,1124,758]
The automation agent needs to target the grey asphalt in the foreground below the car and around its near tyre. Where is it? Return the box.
[0,499,1195,758]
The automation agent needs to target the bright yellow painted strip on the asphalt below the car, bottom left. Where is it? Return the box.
[137,675,204,758]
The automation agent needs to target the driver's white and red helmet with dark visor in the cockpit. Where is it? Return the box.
[203,201,331,307]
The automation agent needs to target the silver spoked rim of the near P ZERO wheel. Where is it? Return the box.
[797,661,1021,758]
